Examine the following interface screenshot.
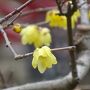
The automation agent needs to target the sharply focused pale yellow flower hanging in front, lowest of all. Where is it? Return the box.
[32,46,57,73]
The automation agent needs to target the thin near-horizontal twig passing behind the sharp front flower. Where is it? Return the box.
[15,46,76,60]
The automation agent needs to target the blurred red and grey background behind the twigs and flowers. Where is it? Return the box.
[0,0,90,88]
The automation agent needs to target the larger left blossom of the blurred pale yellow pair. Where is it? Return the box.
[20,25,39,45]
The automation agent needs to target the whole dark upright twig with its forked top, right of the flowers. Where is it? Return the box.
[56,0,78,83]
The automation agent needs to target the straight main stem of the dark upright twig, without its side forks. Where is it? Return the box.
[67,4,77,79]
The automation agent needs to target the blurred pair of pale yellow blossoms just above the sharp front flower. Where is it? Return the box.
[20,25,52,48]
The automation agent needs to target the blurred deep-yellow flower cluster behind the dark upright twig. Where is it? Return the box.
[46,10,80,29]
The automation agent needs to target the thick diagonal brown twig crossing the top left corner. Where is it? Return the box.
[0,0,32,24]
